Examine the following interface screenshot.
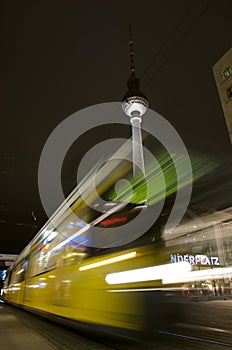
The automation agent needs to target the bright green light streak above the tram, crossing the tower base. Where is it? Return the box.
[108,152,218,205]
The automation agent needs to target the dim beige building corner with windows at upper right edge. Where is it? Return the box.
[213,48,232,143]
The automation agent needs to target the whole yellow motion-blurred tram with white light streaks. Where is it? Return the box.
[3,155,226,334]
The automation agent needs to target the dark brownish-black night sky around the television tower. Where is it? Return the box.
[0,0,232,254]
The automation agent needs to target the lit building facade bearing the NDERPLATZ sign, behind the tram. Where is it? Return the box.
[165,207,232,299]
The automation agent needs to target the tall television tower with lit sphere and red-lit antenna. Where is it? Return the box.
[122,26,148,177]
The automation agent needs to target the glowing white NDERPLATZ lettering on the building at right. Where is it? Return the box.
[170,254,220,266]
